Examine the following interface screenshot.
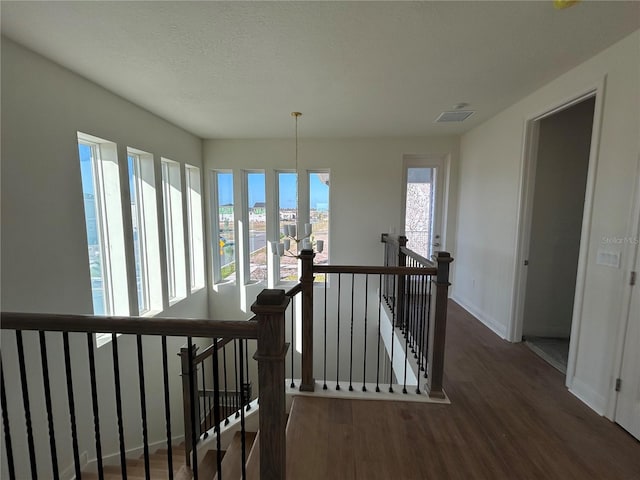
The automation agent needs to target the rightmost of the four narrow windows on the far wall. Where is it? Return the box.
[309,171,329,276]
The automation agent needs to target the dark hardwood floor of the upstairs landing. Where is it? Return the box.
[287,303,640,480]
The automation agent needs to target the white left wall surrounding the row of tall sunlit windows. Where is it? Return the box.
[1,38,207,478]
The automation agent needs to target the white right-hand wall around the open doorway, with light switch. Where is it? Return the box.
[453,31,640,412]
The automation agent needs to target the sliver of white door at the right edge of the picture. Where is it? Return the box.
[616,242,640,440]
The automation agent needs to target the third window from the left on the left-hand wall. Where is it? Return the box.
[161,158,187,304]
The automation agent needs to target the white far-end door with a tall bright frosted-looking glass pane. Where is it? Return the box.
[403,156,445,258]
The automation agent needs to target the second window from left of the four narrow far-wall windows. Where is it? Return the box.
[244,172,267,282]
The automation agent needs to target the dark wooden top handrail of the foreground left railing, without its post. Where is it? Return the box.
[0,312,258,339]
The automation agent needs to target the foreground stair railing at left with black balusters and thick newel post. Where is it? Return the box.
[0,290,289,479]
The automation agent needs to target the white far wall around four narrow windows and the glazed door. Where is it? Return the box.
[204,137,458,319]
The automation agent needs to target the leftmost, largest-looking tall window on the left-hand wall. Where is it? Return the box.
[78,132,129,324]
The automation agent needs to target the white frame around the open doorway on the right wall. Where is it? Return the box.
[507,76,606,394]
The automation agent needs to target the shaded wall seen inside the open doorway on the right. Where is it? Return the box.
[522,97,595,338]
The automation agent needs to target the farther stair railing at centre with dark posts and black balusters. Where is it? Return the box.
[288,234,453,399]
